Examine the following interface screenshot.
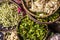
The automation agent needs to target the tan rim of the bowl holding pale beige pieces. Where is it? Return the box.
[21,0,59,18]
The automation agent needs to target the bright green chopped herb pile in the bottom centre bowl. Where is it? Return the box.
[18,15,48,40]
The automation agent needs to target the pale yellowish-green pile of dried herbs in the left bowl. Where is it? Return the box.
[0,1,21,27]
